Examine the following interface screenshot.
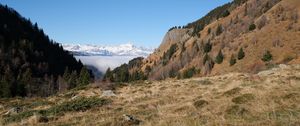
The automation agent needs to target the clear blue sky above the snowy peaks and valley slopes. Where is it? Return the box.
[0,0,231,47]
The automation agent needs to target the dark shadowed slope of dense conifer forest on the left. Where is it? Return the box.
[0,5,92,97]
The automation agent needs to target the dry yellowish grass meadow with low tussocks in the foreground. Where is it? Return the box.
[0,65,300,126]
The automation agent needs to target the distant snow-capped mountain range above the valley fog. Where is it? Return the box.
[62,43,153,57]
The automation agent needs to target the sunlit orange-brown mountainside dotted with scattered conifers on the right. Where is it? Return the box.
[105,0,300,80]
